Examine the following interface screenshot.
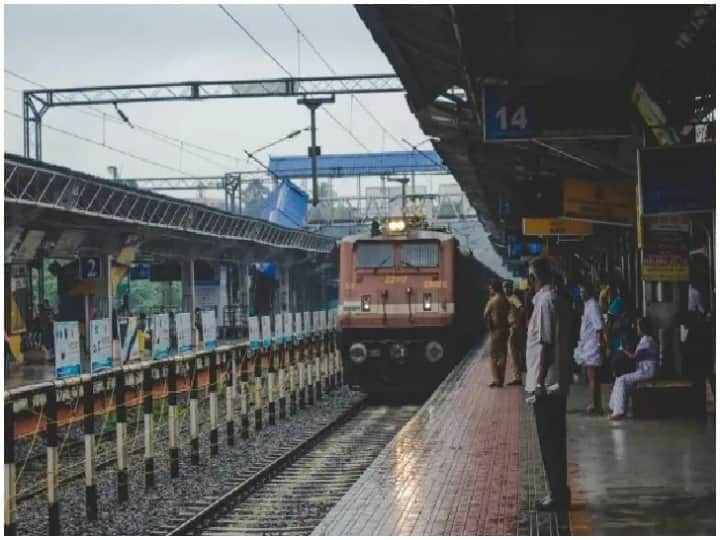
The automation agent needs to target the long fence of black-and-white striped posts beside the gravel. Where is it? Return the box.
[4,331,343,535]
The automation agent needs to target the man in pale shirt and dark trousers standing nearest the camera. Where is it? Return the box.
[525,257,570,512]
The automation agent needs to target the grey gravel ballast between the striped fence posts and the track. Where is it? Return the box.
[17,387,364,535]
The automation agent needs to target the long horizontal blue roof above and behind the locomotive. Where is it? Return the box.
[269,150,448,179]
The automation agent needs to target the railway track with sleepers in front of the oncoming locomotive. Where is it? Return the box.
[162,402,419,535]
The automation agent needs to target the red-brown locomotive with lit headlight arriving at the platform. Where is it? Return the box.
[338,218,496,393]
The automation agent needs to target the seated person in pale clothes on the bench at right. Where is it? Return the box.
[609,317,659,420]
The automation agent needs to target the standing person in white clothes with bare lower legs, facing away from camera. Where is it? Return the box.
[573,284,605,414]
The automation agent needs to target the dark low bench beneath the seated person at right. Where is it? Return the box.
[630,379,706,418]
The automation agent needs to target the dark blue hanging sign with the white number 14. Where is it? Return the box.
[482,82,631,142]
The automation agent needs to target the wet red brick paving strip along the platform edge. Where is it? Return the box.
[313,350,523,535]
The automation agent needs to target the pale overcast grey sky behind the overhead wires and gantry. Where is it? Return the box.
[4,4,506,274]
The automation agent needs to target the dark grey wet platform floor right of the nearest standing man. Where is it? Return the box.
[568,385,715,535]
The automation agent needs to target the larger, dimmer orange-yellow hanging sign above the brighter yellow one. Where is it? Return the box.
[563,178,635,225]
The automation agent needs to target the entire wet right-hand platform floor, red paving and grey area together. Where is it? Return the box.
[313,342,715,536]
